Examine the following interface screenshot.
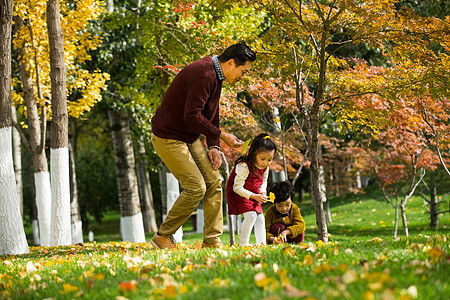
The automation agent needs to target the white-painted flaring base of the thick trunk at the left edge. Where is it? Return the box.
[0,127,29,255]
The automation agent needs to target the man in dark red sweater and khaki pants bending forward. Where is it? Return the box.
[151,42,256,249]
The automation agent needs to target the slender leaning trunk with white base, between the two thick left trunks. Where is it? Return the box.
[14,17,51,246]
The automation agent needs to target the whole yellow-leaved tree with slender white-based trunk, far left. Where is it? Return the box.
[12,0,108,246]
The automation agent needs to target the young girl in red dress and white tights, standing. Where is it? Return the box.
[226,133,277,246]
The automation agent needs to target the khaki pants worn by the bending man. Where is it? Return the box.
[152,135,223,244]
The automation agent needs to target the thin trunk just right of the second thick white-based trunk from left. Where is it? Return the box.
[69,143,83,244]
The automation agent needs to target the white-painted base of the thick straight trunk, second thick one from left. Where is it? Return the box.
[50,148,72,246]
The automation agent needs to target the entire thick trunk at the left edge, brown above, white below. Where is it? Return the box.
[0,0,29,255]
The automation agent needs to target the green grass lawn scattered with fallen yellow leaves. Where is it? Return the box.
[4,191,450,300]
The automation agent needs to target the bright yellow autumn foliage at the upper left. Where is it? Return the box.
[12,0,109,118]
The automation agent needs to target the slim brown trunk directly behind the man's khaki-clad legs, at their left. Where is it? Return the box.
[136,140,158,232]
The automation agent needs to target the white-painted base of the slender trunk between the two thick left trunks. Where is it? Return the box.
[34,172,52,247]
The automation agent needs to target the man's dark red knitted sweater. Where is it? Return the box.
[152,56,222,147]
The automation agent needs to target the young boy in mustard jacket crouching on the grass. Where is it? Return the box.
[265,181,305,244]
